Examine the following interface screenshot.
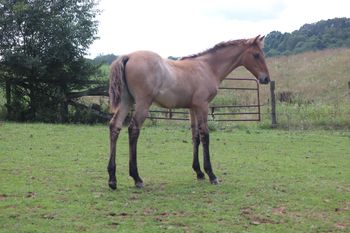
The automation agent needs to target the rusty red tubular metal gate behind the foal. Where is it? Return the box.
[148,78,261,121]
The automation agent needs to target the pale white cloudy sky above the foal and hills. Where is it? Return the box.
[88,0,350,58]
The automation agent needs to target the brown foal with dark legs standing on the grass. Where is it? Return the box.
[107,35,270,189]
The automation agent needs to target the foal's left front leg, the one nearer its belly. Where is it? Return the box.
[190,110,205,180]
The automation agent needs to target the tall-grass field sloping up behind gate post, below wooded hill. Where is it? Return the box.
[224,48,350,130]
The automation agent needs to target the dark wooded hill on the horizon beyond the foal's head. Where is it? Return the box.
[264,18,350,57]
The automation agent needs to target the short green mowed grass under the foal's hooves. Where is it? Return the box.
[0,122,350,232]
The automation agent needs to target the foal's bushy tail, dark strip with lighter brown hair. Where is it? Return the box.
[109,56,129,113]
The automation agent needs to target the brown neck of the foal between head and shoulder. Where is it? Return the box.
[202,45,246,83]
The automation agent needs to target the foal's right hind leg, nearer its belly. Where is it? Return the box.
[128,101,151,188]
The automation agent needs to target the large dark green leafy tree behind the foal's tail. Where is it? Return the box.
[0,0,106,122]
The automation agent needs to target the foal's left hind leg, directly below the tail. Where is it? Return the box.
[107,100,131,189]
